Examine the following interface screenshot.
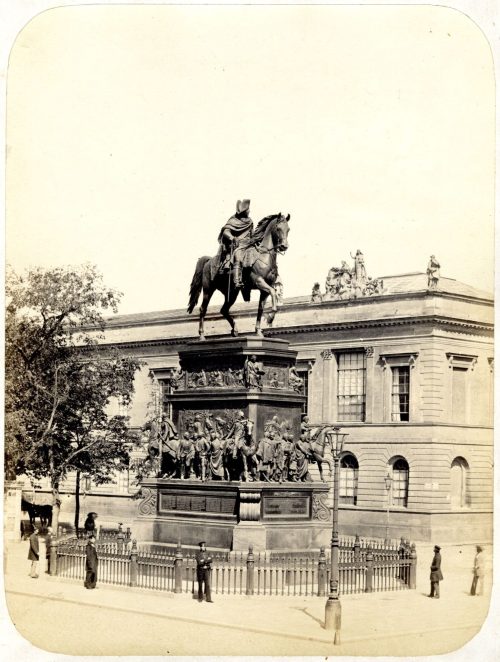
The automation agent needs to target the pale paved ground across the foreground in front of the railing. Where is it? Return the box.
[0,542,494,662]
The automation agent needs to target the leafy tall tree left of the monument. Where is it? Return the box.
[5,265,140,527]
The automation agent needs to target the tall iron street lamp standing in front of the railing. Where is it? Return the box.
[325,427,347,644]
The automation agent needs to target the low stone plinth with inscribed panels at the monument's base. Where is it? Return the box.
[133,479,331,550]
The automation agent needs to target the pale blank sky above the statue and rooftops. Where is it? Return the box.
[6,5,495,314]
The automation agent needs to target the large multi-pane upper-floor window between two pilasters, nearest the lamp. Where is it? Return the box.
[337,351,366,421]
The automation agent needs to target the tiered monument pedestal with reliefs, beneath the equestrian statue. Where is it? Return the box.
[134,336,331,550]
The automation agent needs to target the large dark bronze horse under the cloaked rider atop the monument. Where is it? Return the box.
[187,213,290,340]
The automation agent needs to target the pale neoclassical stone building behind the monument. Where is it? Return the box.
[29,273,493,543]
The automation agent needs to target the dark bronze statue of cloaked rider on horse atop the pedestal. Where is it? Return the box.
[187,200,290,340]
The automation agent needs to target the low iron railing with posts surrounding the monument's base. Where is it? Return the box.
[51,537,417,597]
